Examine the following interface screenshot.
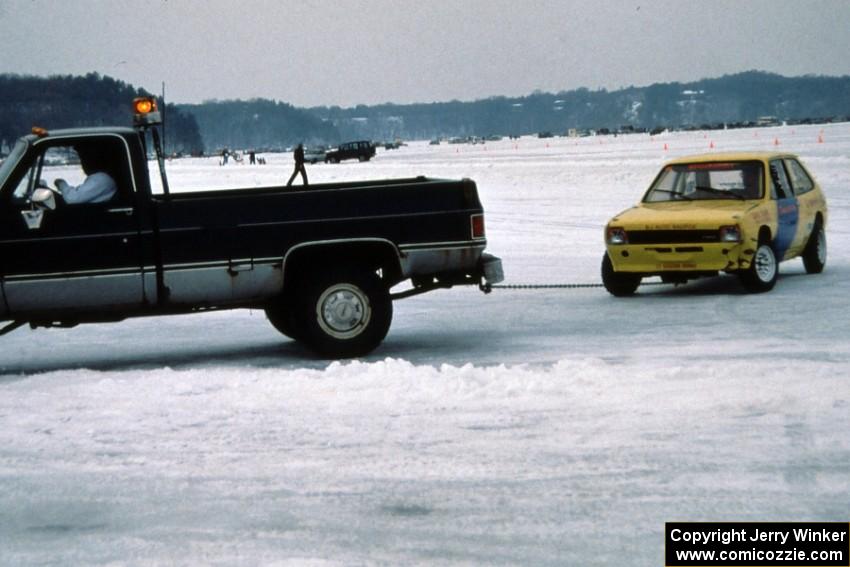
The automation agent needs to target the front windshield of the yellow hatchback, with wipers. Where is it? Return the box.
[643,161,764,203]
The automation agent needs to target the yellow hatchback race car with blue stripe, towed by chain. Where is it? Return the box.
[602,152,827,296]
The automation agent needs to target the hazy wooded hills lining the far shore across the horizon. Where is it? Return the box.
[0,71,850,158]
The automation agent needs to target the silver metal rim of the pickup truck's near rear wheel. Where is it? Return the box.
[316,283,372,339]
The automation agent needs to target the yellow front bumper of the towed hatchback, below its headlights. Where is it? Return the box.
[608,242,755,275]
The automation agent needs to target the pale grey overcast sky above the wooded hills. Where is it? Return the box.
[0,0,850,106]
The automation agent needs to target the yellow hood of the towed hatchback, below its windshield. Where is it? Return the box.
[609,201,753,230]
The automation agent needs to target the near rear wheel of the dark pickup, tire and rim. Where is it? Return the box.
[297,268,393,358]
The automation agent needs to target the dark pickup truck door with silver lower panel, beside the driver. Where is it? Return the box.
[0,135,143,320]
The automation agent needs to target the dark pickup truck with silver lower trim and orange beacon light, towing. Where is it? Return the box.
[0,101,502,358]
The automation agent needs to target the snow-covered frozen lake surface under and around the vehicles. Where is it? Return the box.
[0,124,850,566]
